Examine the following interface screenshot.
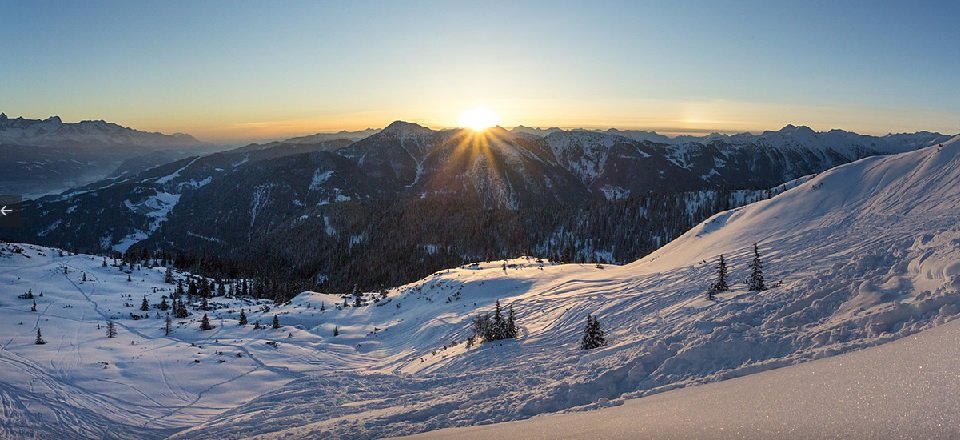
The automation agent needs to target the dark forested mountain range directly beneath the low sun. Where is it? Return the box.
[4,121,949,290]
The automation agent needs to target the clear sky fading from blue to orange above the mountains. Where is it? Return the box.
[0,0,960,142]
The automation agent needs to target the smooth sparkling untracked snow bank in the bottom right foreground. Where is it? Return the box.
[412,314,960,440]
